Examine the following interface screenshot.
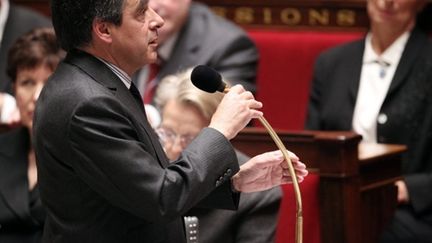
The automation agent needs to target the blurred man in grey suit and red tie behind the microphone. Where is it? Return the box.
[134,0,258,107]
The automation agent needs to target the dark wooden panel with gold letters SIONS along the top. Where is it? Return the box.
[12,0,432,31]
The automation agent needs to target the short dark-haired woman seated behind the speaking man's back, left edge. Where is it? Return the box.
[0,28,64,243]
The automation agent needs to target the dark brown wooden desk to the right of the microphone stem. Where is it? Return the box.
[232,128,406,243]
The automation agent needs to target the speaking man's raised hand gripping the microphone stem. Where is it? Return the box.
[209,85,262,139]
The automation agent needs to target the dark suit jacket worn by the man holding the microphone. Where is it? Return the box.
[34,51,239,243]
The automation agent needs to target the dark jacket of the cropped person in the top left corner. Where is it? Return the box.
[0,3,51,92]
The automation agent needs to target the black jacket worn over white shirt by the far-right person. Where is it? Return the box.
[306,29,432,239]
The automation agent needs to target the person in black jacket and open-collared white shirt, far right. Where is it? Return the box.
[306,0,432,242]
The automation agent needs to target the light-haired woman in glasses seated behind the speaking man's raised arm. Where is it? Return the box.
[155,70,288,243]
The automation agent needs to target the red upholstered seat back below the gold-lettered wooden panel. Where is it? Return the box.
[248,29,363,130]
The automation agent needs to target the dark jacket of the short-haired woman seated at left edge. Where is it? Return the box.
[0,128,45,243]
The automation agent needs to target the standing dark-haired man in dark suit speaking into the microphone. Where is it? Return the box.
[33,0,304,243]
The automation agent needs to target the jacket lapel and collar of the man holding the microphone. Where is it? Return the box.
[65,50,169,167]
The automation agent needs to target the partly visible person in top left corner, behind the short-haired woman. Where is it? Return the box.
[0,0,51,124]
